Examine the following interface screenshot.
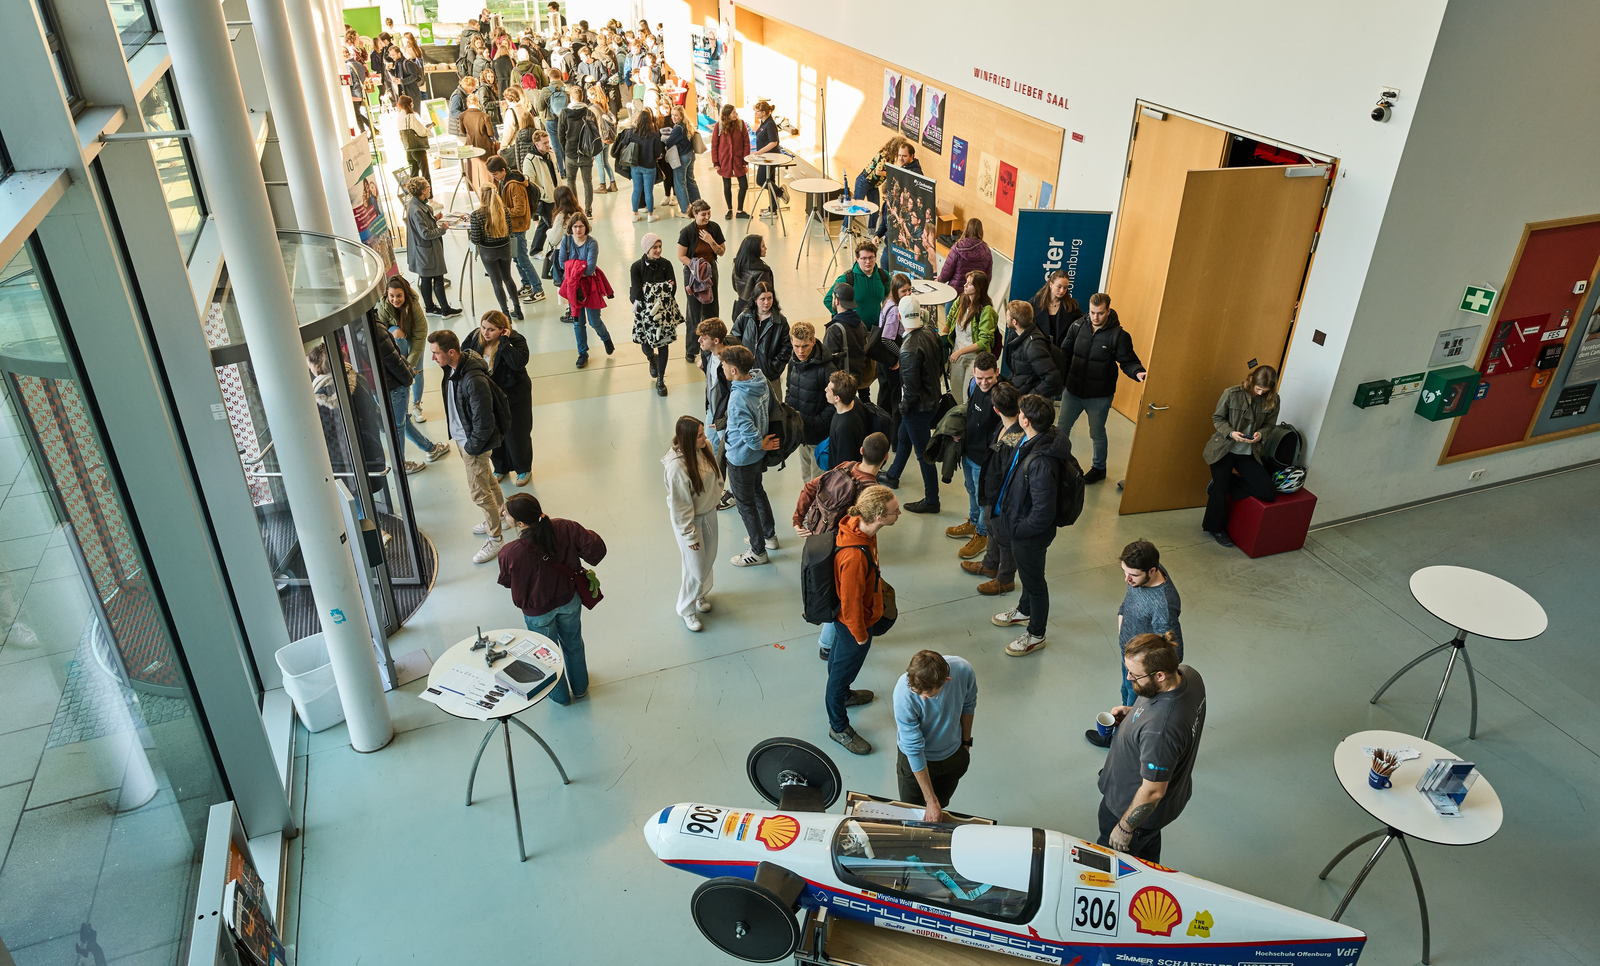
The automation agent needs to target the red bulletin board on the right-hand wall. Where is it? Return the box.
[1438,214,1600,464]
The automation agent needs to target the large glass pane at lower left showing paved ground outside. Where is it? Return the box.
[0,239,227,966]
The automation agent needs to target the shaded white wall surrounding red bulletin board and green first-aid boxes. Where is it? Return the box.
[1312,0,1600,520]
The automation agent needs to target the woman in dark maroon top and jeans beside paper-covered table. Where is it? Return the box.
[499,493,605,704]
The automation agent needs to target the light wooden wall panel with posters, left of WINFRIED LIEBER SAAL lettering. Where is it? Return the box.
[736,6,1066,254]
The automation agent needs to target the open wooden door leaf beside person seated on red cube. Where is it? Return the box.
[1112,165,1328,513]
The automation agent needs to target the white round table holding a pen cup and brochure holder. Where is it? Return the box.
[1317,729,1504,963]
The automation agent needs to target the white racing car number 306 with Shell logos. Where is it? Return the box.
[645,737,1366,966]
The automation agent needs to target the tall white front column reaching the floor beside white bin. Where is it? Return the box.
[157,0,394,752]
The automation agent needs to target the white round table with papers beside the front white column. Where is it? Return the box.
[427,627,571,862]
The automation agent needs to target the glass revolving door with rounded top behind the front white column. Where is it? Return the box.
[205,232,438,688]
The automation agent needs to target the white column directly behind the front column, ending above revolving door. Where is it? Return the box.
[250,0,329,235]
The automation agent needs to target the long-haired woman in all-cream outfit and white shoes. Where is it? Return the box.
[661,416,722,630]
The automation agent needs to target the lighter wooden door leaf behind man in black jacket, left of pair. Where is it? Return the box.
[1107,109,1227,419]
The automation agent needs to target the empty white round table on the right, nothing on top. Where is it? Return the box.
[1370,566,1550,739]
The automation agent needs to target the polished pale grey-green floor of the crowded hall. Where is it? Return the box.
[285,147,1600,966]
